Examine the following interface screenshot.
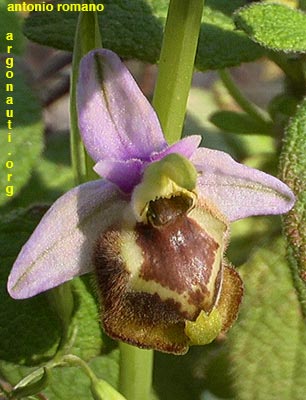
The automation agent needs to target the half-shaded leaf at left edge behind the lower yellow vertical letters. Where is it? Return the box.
[0,62,43,205]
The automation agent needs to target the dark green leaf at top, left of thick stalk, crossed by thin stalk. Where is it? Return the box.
[24,0,166,63]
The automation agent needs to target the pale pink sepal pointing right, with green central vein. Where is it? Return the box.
[191,148,294,221]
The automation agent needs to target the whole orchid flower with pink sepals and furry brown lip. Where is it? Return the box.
[8,50,294,354]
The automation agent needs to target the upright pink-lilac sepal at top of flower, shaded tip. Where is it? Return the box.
[77,49,167,161]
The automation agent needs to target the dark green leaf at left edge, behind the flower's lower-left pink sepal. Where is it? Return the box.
[0,207,60,372]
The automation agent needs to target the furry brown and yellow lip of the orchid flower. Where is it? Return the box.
[94,196,242,354]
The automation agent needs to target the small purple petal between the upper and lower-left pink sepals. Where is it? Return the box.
[94,159,146,193]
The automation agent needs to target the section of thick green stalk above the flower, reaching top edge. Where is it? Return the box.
[153,0,204,143]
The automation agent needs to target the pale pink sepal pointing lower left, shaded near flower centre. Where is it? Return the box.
[8,180,126,299]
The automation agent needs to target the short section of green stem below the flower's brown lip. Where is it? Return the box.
[119,343,153,400]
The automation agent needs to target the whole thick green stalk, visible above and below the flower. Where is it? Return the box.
[119,0,204,400]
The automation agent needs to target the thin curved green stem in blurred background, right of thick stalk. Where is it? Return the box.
[218,69,272,128]
